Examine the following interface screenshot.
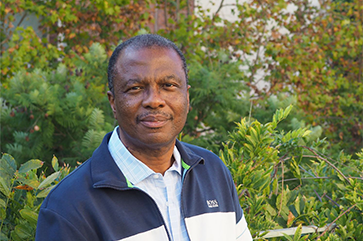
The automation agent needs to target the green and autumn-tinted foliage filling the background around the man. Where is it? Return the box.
[0,0,363,240]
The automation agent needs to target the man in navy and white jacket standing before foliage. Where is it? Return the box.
[36,35,252,241]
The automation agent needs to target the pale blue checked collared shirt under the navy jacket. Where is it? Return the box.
[108,127,189,241]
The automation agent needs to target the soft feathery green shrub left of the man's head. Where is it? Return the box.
[0,44,113,166]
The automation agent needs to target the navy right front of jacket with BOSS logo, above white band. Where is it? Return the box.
[178,142,241,220]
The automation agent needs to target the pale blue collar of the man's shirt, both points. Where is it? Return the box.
[108,126,181,185]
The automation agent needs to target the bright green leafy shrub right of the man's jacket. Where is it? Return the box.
[220,106,363,240]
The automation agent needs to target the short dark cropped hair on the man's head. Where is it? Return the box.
[108,34,188,94]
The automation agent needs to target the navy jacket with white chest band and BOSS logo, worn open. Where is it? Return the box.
[36,133,252,241]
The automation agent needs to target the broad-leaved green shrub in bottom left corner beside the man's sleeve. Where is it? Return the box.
[0,154,70,241]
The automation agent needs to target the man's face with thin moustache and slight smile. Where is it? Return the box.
[108,47,189,149]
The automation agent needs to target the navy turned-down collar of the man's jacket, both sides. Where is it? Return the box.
[89,132,204,190]
